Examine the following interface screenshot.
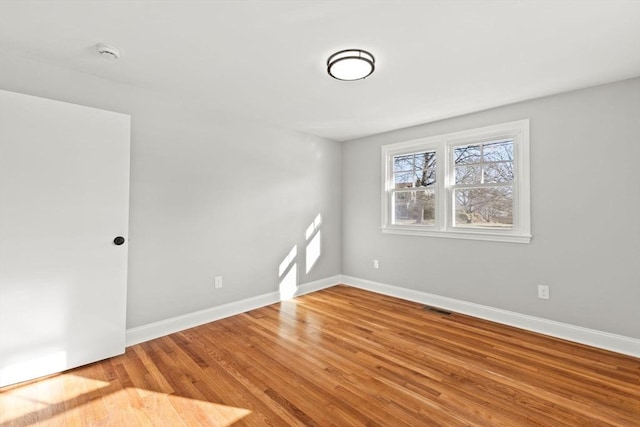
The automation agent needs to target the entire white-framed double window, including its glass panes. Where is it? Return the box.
[382,120,531,243]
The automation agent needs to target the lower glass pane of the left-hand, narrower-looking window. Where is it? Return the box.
[393,190,436,225]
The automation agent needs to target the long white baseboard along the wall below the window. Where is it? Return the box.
[341,275,640,357]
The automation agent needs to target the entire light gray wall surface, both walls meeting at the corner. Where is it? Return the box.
[0,53,640,338]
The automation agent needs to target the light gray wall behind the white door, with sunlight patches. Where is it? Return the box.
[0,53,342,328]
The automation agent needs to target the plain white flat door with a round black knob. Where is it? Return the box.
[0,91,130,386]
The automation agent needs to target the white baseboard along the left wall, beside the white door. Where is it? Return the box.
[125,275,341,347]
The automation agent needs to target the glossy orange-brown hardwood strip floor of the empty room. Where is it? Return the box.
[0,286,640,427]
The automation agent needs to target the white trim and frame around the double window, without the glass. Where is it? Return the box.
[381,119,531,243]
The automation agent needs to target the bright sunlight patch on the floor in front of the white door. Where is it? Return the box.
[0,382,251,427]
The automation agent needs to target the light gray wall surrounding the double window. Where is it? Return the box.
[342,79,640,338]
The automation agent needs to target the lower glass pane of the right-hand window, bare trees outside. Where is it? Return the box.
[454,186,513,228]
